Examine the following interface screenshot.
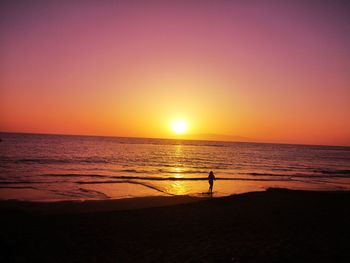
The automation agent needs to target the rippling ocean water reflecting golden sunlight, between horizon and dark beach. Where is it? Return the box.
[0,133,350,201]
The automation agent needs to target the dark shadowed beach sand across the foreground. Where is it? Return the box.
[0,189,350,262]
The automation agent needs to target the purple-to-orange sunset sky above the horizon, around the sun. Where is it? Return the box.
[0,0,350,146]
